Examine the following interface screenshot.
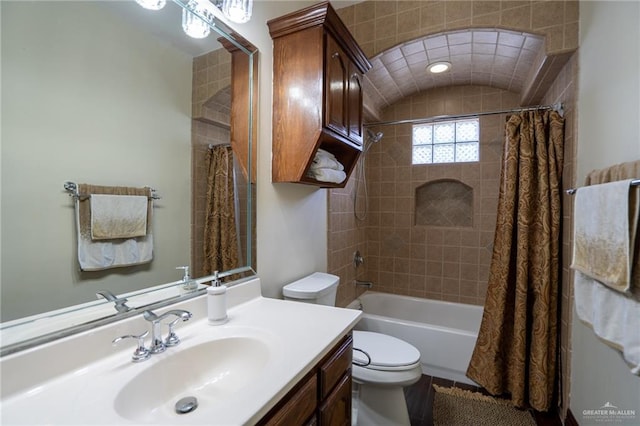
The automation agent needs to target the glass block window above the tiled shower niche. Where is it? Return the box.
[412,118,480,164]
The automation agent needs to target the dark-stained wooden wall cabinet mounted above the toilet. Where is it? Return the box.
[267,2,371,188]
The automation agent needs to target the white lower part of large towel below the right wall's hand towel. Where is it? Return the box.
[574,271,640,375]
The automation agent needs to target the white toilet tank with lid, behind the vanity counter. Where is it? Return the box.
[282,272,340,306]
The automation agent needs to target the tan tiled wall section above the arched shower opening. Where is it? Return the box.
[338,0,578,61]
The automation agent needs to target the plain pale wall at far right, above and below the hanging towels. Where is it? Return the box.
[571,1,640,425]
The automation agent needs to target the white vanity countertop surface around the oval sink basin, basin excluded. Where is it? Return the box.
[0,279,361,425]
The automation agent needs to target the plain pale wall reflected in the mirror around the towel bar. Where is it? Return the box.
[1,2,191,319]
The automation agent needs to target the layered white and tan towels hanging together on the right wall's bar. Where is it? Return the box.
[571,162,640,375]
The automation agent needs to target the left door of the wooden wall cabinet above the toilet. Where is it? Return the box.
[324,34,349,136]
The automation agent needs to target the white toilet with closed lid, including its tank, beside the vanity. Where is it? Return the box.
[282,272,422,426]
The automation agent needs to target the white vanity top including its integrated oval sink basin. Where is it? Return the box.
[0,279,361,426]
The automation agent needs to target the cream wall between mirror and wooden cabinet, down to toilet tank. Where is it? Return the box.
[238,1,327,297]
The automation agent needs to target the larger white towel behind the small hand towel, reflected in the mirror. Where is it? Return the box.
[76,201,153,271]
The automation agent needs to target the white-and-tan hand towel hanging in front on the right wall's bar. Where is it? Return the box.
[571,179,640,293]
